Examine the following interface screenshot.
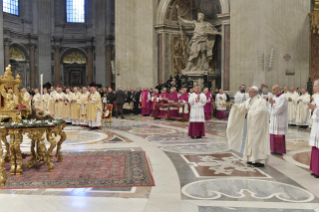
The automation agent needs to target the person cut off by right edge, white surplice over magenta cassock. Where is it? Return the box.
[308,79,319,178]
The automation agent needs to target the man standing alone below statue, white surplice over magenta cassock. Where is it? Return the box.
[188,86,207,138]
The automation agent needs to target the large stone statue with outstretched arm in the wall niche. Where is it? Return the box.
[178,13,220,73]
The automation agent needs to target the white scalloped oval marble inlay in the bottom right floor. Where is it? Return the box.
[182,179,315,202]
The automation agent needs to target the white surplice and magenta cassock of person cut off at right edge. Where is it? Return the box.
[309,95,319,176]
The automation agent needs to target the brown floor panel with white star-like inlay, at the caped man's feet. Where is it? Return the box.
[182,152,271,178]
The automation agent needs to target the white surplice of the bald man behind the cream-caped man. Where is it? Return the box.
[269,94,288,135]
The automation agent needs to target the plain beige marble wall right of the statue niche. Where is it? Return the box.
[230,0,311,92]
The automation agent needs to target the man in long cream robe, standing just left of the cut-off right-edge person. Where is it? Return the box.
[296,88,310,128]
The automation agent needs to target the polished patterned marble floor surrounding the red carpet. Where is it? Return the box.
[0,115,319,212]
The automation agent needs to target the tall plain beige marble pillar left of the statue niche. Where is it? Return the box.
[115,0,157,88]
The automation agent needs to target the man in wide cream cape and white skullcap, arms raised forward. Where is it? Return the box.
[226,86,270,167]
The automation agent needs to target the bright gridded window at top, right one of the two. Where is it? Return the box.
[66,0,85,23]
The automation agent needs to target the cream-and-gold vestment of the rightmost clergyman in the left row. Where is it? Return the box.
[88,91,102,128]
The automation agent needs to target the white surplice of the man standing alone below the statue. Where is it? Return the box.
[188,93,207,123]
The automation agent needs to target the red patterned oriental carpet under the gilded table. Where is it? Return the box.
[3,151,154,189]
